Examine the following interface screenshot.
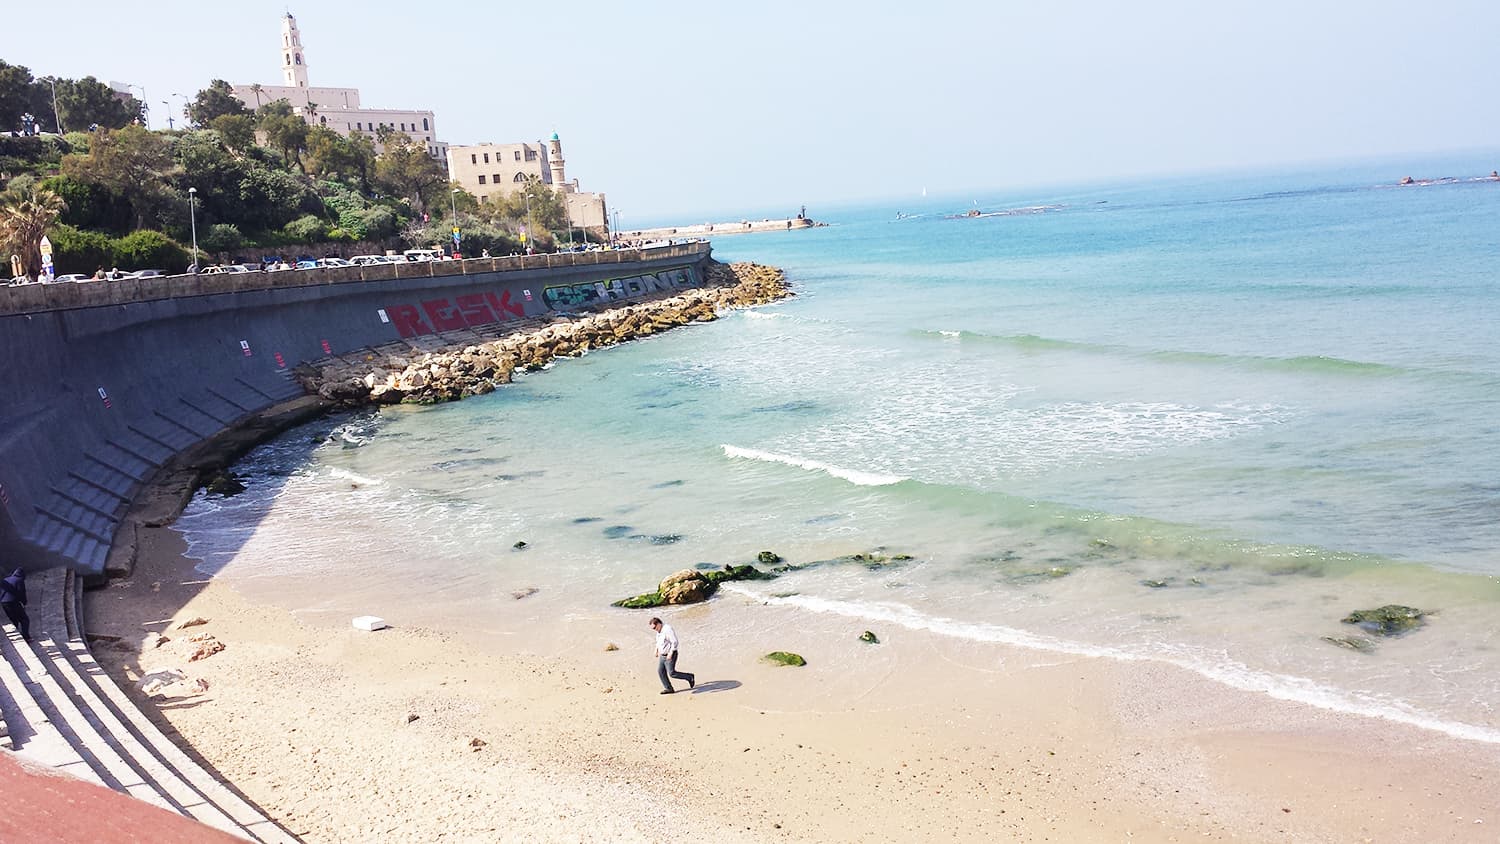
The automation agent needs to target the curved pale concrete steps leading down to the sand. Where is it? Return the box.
[0,568,296,843]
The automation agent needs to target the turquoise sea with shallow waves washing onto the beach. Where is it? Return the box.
[179,154,1500,744]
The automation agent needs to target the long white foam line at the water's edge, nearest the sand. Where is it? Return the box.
[722,583,1500,744]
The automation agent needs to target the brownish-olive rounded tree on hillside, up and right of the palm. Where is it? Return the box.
[63,126,176,228]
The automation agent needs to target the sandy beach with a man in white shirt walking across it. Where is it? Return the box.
[87,528,1500,841]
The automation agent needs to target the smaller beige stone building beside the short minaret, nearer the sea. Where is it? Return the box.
[449,132,609,229]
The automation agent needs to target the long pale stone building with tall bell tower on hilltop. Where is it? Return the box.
[225,12,447,160]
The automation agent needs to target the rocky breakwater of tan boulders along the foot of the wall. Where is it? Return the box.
[307,261,792,406]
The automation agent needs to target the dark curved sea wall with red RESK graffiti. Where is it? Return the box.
[0,243,711,574]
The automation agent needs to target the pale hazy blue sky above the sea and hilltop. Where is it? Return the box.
[0,0,1500,226]
